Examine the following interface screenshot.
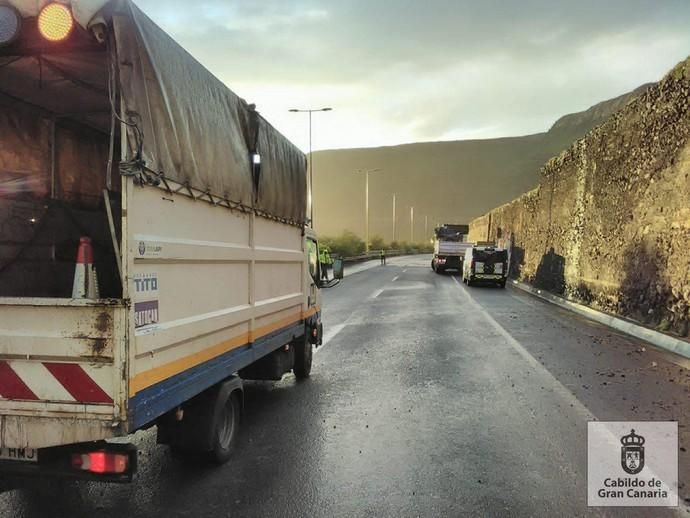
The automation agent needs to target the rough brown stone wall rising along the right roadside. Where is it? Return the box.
[470,59,690,336]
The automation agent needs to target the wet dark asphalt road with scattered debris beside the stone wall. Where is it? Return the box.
[0,257,690,518]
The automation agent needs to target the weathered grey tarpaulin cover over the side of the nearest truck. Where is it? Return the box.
[113,0,307,223]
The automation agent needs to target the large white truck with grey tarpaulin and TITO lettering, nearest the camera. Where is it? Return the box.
[0,0,332,482]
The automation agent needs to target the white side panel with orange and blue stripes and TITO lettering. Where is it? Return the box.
[126,185,306,431]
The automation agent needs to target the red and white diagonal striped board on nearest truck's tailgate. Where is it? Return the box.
[0,361,113,404]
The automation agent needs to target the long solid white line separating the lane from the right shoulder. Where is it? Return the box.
[453,277,690,516]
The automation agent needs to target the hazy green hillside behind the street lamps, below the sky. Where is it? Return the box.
[314,85,648,241]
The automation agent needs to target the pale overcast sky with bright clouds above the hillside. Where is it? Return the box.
[137,0,690,151]
